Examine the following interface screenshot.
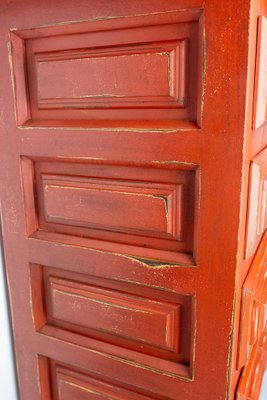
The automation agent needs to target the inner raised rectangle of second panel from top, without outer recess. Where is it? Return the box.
[42,175,183,239]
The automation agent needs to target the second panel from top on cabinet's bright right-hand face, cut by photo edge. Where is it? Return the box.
[245,149,267,258]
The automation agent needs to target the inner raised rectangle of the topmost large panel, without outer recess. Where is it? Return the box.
[36,40,186,109]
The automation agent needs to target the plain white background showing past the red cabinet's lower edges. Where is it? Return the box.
[0,239,267,400]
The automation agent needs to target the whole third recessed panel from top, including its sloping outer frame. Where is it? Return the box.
[30,264,194,376]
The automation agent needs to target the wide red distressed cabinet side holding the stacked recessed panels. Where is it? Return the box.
[0,0,249,400]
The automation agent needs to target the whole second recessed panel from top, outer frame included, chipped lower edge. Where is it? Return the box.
[22,158,195,262]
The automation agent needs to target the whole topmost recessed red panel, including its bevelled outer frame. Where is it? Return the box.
[10,9,203,128]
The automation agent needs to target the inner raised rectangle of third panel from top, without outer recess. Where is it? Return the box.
[49,277,180,352]
